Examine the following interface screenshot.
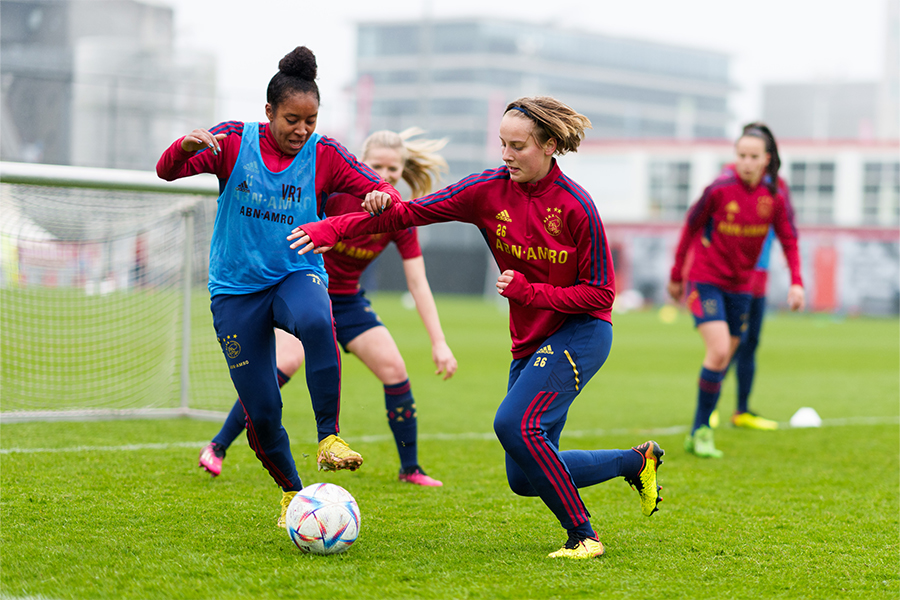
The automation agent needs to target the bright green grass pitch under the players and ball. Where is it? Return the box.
[0,295,900,599]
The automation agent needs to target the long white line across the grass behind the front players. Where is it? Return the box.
[0,417,900,454]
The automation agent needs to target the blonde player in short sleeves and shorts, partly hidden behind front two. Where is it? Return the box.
[200,129,457,487]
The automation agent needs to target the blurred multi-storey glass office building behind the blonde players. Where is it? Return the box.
[354,19,734,293]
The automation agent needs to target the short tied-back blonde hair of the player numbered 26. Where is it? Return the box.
[503,96,592,155]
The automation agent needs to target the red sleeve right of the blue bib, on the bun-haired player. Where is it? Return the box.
[316,135,401,213]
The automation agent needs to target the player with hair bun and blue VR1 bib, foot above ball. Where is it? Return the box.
[156,46,400,527]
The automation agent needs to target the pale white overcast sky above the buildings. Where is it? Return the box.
[165,0,898,136]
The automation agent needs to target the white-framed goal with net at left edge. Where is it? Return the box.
[0,162,236,423]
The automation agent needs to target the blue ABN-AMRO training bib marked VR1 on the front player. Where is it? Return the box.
[209,123,328,296]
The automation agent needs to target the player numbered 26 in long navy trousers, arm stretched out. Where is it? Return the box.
[288,97,664,558]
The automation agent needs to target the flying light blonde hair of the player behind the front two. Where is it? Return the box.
[362,127,447,198]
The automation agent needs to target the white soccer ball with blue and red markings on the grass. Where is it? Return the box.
[285,483,360,554]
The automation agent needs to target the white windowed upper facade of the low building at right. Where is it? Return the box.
[559,140,900,228]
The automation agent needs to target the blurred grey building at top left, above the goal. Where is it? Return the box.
[0,0,216,170]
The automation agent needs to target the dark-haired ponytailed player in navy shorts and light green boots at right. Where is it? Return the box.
[668,123,804,458]
